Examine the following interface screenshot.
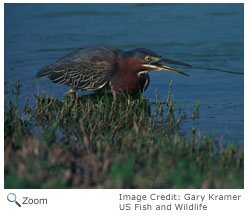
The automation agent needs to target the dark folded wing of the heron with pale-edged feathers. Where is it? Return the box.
[37,47,120,91]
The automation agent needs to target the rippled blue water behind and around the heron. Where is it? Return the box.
[4,4,244,143]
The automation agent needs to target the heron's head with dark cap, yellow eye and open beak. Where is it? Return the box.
[127,48,191,76]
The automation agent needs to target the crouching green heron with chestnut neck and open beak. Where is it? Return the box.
[36,46,191,94]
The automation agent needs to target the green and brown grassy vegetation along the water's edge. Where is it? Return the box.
[4,80,244,188]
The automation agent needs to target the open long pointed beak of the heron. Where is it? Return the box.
[144,58,192,76]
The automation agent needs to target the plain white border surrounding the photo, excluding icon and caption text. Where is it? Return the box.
[0,0,250,216]
